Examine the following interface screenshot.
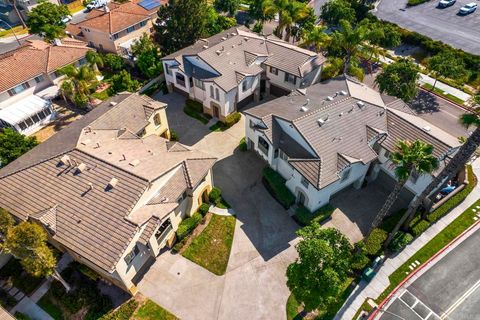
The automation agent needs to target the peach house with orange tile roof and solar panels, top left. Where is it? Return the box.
[66,2,160,58]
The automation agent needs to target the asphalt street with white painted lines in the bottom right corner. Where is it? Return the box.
[380,230,480,320]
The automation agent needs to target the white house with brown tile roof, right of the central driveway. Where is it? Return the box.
[246,77,460,211]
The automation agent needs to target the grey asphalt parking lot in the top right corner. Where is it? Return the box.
[374,0,480,54]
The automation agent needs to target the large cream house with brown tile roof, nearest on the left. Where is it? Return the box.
[0,94,216,293]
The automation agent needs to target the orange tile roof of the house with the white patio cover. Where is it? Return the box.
[0,39,91,92]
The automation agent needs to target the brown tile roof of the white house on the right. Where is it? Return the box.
[246,77,460,188]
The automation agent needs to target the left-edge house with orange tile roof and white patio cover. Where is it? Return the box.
[0,38,91,135]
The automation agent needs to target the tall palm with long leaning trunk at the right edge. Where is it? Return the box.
[385,113,480,247]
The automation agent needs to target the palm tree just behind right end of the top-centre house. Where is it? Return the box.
[329,19,368,77]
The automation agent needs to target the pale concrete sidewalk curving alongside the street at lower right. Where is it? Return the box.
[334,159,480,320]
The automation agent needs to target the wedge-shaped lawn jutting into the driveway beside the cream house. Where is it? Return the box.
[183,215,236,275]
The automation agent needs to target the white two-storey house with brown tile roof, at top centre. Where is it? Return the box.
[163,27,325,120]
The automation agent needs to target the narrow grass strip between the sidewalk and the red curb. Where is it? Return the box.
[376,200,480,303]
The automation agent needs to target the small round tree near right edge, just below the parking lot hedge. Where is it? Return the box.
[427,51,468,91]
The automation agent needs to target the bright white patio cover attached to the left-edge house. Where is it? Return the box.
[0,95,50,126]
